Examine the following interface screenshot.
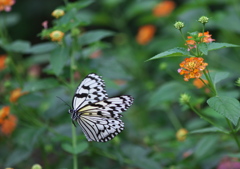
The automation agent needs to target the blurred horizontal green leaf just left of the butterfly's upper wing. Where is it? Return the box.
[23,78,59,92]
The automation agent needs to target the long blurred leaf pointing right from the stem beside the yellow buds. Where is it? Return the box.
[78,30,114,45]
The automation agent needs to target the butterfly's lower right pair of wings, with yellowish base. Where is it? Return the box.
[77,95,133,142]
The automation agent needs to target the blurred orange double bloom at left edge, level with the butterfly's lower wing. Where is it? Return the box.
[0,106,17,135]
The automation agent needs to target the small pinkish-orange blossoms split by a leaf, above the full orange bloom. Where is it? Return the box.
[185,31,215,50]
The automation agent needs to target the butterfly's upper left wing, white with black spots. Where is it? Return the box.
[72,73,108,110]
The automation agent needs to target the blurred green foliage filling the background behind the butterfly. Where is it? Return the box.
[0,0,240,169]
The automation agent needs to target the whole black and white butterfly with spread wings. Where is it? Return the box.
[69,73,133,142]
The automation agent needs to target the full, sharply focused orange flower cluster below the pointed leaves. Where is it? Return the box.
[178,57,208,81]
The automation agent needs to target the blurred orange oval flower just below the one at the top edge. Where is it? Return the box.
[136,25,156,45]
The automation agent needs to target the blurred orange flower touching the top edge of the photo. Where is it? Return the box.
[153,1,176,17]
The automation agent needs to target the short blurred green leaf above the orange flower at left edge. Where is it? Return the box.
[7,40,31,53]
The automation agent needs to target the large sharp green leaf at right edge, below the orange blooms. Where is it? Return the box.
[207,96,240,126]
